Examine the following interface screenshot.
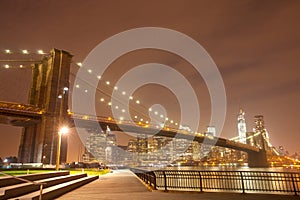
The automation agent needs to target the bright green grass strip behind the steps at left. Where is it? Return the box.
[0,169,110,176]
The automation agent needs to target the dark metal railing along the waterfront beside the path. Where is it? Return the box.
[132,169,300,196]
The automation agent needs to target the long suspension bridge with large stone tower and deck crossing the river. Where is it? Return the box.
[0,49,274,167]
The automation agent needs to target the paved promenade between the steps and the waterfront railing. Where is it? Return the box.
[58,170,300,200]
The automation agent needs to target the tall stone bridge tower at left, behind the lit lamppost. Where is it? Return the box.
[18,49,72,164]
